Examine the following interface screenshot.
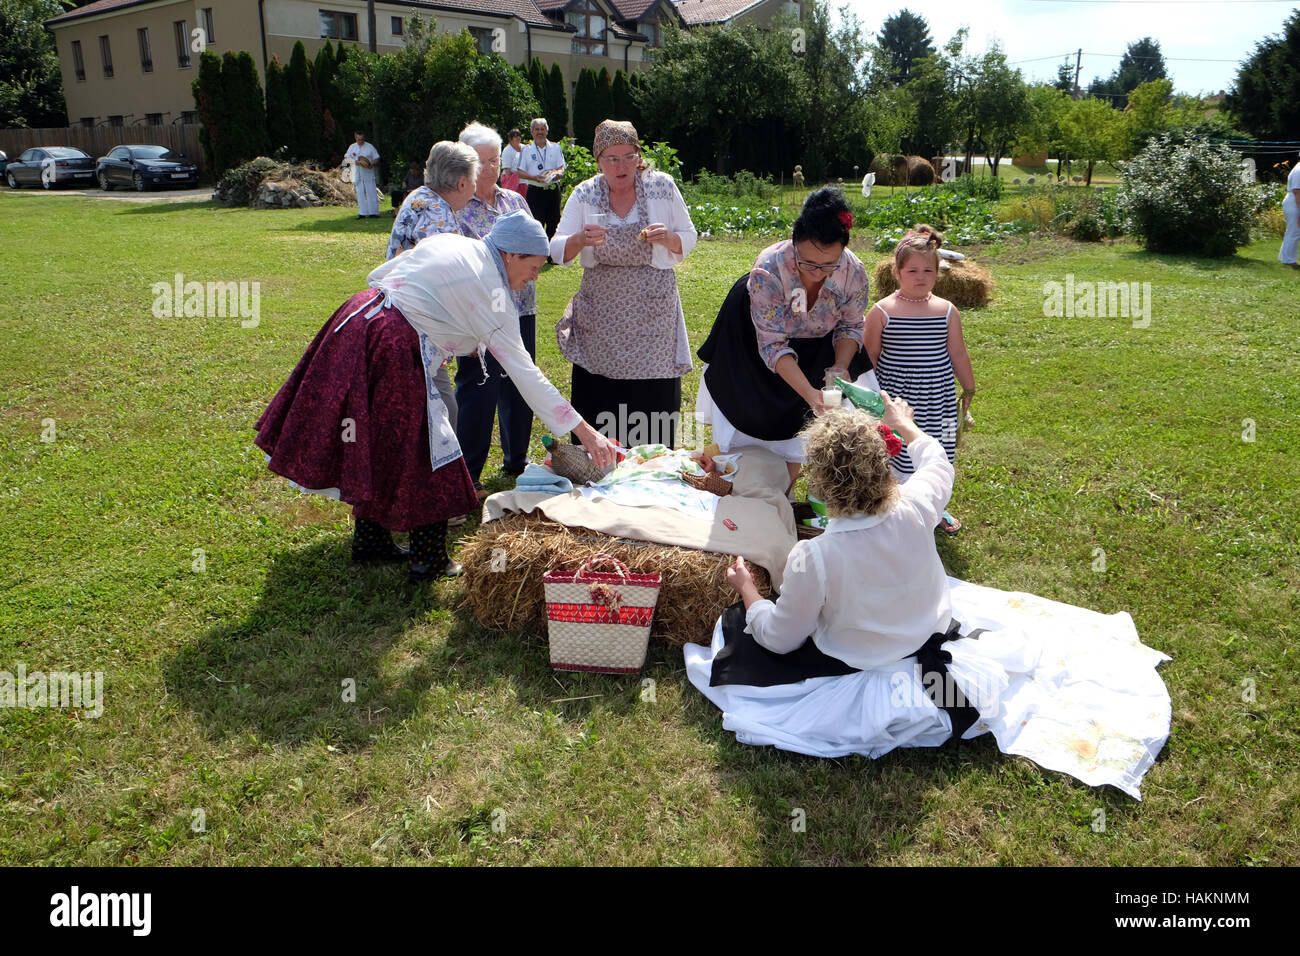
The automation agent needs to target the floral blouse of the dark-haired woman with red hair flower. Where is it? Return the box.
[748,239,867,372]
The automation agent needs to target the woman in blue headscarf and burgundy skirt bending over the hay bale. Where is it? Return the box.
[256,212,615,579]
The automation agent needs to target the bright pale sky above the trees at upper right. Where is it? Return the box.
[828,0,1300,95]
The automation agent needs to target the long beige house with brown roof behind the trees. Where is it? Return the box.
[46,0,798,126]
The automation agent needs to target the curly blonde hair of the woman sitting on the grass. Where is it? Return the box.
[800,408,898,518]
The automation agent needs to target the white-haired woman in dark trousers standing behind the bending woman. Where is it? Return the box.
[456,122,537,488]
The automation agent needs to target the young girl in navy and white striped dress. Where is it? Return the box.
[863,225,975,535]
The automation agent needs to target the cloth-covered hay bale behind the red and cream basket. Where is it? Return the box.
[458,514,772,645]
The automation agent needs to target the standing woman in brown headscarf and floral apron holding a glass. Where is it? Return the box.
[551,120,697,446]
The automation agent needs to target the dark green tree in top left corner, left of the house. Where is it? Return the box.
[0,0,68,129]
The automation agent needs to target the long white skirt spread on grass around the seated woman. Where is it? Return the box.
[685,578,1170,800]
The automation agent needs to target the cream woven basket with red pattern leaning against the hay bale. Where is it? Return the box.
[542,554,663,674]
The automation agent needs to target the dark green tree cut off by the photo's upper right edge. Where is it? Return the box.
[1223,10,1300,142]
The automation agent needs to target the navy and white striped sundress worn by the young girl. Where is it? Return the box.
[876,303,957,479]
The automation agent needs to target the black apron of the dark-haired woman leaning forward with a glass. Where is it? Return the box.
[696,273,871,441]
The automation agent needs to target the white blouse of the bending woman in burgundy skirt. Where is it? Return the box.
[368,233,582,436]
